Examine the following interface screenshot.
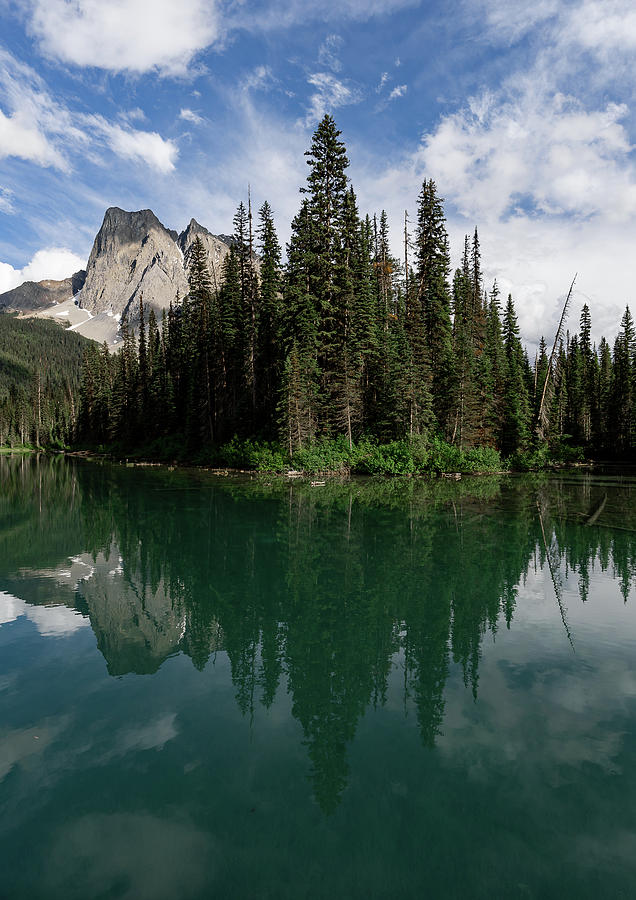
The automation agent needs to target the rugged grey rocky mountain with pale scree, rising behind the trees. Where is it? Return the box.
[0,206,231,348]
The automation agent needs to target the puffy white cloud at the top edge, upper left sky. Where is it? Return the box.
[29,0,221,76]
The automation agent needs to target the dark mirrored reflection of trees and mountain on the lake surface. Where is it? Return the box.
[0,458,636,811]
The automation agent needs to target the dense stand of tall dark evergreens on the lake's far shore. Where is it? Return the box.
[14,115,636,464]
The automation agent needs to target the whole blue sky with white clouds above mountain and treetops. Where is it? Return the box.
[0,0,636,346]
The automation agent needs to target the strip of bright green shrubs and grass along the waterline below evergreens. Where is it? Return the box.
[73,437,583,475]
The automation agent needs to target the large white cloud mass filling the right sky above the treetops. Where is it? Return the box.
[357,0,636,343]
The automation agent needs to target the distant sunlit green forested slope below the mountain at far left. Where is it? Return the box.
[0,315,90,447]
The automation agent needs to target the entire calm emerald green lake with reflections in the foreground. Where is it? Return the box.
[0,458,636,900]
